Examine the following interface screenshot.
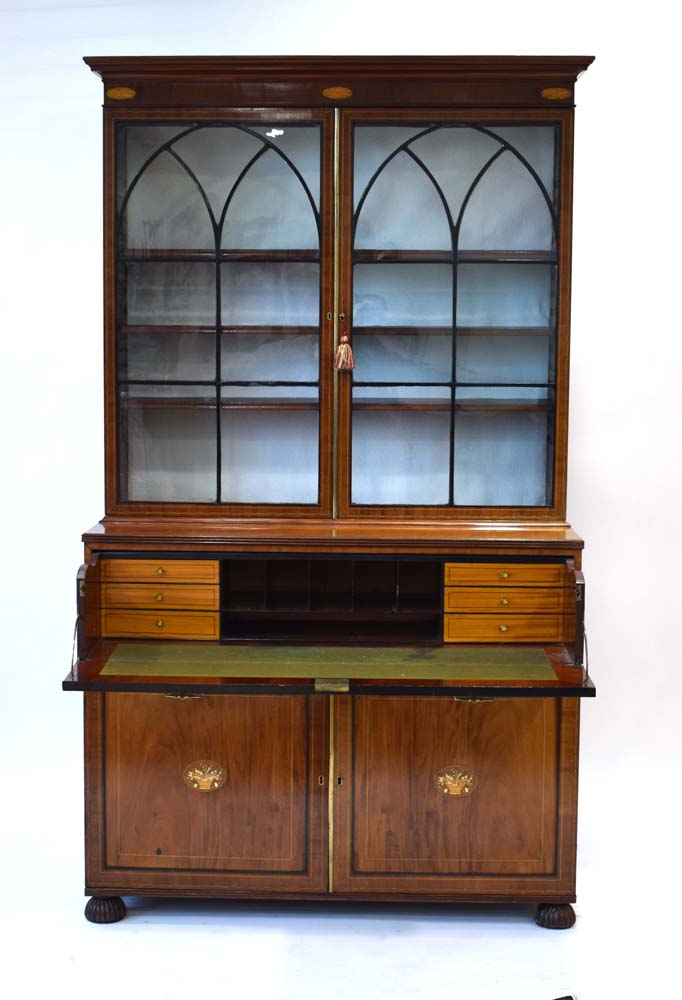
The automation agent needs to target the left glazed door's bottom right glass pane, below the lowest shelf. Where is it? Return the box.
[222,404,319,504]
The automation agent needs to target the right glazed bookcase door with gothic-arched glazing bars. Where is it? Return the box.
[339,110,568,518]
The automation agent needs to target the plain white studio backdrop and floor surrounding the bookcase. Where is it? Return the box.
[0,0,682,1000]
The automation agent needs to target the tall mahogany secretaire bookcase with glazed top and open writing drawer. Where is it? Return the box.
[64,56,594,927]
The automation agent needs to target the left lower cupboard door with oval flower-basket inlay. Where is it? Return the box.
[100,694,327,891]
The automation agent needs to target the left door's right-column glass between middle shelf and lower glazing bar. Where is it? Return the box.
[221,333,320,382]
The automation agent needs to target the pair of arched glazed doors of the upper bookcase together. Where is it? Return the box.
[108,102,571,520]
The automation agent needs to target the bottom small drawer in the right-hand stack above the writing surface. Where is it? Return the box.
[443,615,575,643]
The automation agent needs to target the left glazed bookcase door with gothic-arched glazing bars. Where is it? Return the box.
[108,112,333,515]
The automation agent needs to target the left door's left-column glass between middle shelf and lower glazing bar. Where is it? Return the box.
[119,328,215,382]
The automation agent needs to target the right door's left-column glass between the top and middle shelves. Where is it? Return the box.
[353,264,452,327]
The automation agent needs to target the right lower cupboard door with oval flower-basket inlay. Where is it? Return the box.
[333,697,572,895]
